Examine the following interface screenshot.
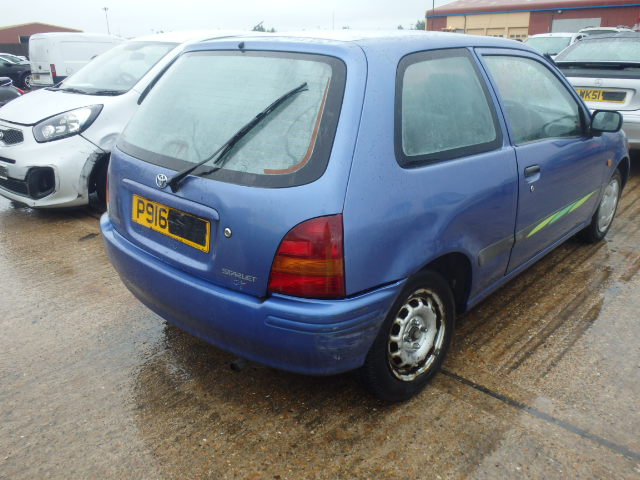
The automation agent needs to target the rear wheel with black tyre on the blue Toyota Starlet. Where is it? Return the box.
[360,271,455,402]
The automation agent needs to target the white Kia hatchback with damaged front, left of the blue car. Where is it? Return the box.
[0,30,255,208]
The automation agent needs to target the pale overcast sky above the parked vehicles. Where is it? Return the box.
[5,0,452,37]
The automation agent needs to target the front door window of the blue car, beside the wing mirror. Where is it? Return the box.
[484,55,583,145]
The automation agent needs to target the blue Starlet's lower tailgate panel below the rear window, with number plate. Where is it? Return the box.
[109,149,347,297]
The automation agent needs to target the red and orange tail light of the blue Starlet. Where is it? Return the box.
[269,215,345,298]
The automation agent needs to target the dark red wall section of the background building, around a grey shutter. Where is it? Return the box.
[529,7,640,35]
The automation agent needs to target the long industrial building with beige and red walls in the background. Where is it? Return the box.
[426,0,640,40]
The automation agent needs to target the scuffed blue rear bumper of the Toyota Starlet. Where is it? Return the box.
[100,214,404,375]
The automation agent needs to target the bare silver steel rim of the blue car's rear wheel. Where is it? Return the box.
[387,288,446,382]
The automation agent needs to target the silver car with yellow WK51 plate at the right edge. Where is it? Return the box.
[555,32,640,150]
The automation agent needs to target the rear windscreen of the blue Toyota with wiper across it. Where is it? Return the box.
[118,51,346,187]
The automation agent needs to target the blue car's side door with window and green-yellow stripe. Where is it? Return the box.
[480,49,610,271]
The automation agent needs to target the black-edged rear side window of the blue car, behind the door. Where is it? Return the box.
[395,49,502,166]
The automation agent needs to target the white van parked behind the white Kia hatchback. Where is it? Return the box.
[29,32,123,88]
